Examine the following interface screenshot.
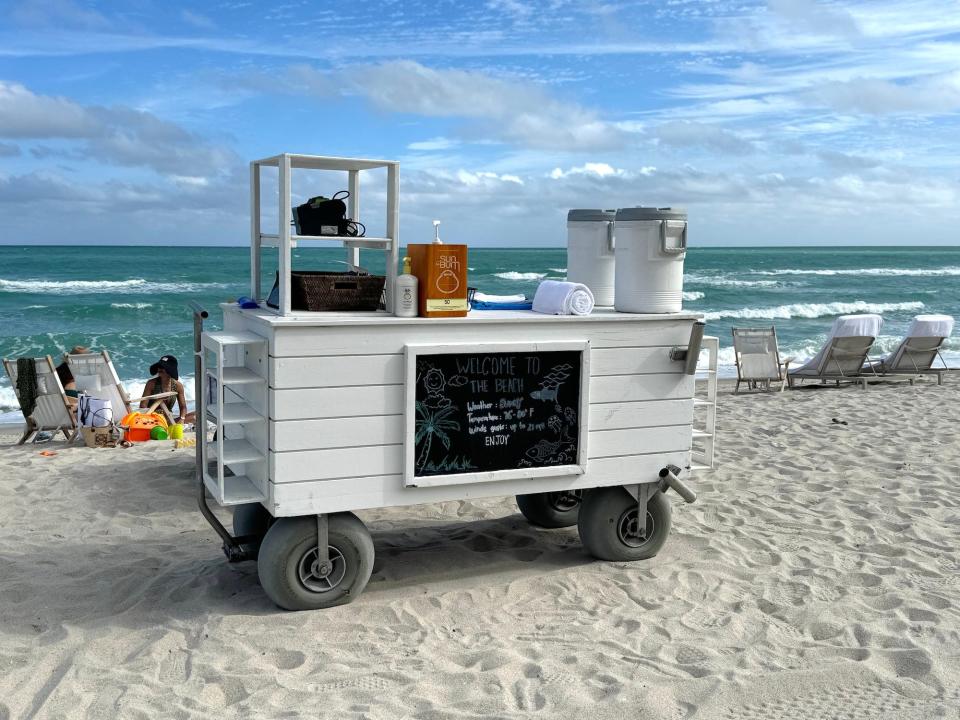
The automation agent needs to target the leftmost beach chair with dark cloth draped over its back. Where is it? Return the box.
[3,355,79,445]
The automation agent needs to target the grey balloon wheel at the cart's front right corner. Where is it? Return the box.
[578,487,671,560]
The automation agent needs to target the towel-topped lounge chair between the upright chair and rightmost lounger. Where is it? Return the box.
[787,315,883,390]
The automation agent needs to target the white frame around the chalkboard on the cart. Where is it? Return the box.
[403,340,590,487]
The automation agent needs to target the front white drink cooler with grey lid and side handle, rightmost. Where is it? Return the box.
[612,207,687,313]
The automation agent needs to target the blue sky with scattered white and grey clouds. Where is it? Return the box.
[0,0,960,247]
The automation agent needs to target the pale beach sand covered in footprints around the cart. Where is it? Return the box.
[0,377,960,720]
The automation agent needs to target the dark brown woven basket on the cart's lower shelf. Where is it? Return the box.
[290,270,387,312]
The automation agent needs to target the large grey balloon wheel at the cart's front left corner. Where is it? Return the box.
[257,513,373,610]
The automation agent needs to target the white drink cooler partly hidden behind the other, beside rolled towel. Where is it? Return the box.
[567,210,617,307]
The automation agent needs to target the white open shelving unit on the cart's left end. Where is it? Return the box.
[201,331,269,505]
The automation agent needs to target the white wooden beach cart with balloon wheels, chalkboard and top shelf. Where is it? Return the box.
[194,155,717,610]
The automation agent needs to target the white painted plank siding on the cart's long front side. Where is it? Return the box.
[230,318,694,516]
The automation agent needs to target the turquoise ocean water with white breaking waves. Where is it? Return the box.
[0,246,960,422]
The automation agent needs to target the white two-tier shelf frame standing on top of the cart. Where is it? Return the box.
[250,153,400,315]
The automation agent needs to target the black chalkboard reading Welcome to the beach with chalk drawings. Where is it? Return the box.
[413,350,581,477]
